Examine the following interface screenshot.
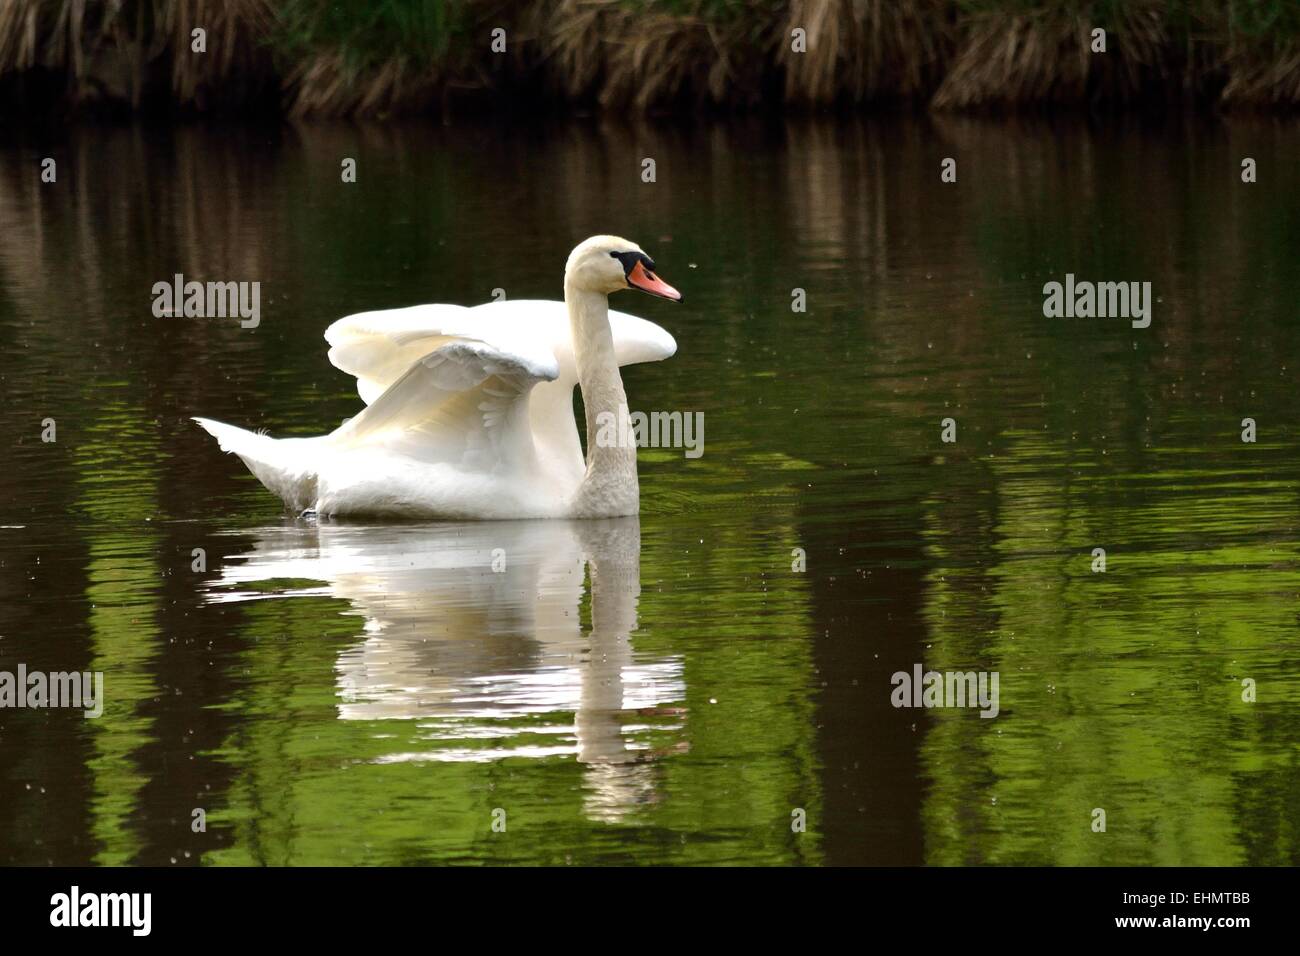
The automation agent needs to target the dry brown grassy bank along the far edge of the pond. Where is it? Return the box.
[0,0,1300,117]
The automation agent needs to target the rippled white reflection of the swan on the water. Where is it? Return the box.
[208,518,685,819]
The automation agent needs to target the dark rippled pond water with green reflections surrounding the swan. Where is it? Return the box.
[0,113,1300,865]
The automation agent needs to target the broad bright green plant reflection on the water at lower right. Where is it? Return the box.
[924,434,1300,865]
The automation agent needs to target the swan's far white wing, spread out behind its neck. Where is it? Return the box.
[325,299,677,405]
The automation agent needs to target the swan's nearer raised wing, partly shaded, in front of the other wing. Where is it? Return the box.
[330,336,559,475]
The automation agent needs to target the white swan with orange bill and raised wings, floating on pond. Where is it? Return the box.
[194,235,681,519]
